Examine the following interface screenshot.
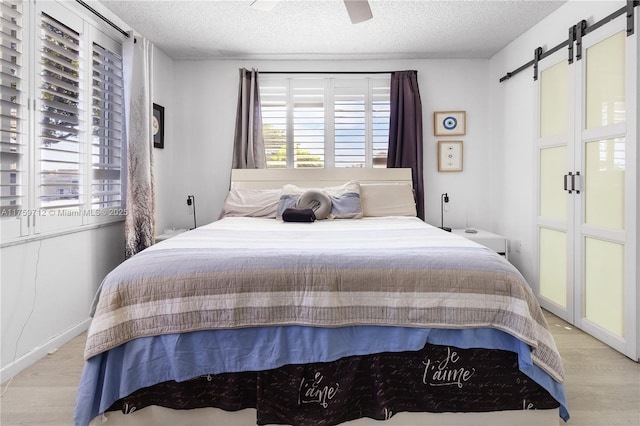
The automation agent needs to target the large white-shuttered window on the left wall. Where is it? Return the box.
[0,1,124,242]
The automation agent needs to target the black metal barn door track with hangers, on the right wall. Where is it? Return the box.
[500,0,640,83]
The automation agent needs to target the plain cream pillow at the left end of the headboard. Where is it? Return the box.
[220,188,280,218]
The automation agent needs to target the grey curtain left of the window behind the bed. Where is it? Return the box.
[232,68,267,169]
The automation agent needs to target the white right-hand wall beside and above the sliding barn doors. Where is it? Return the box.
[488,0,625,283]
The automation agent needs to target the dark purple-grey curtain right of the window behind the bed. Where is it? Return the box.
[387,70,424,220]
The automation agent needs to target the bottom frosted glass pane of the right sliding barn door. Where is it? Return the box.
[584,238,625,337]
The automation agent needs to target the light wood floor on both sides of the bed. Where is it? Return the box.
[0,314,640,426]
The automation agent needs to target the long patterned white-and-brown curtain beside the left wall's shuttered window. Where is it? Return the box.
[123,34,155,258]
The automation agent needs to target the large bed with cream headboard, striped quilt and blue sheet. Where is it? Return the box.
[74,169,569,426]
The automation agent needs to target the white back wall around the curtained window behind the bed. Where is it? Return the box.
[162,60,495,229]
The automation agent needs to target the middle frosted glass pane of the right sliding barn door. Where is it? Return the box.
[584,138,625,229]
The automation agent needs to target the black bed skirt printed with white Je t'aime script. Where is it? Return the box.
[108,344,559,426]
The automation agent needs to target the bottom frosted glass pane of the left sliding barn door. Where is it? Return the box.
[539,228,567,308]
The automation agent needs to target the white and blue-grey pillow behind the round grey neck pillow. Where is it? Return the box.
[277,180,362,219]
